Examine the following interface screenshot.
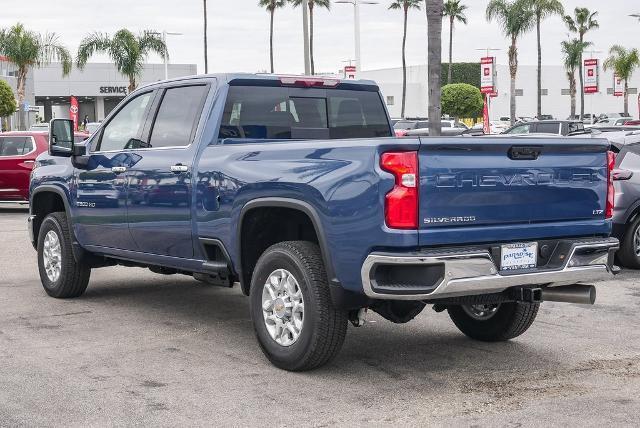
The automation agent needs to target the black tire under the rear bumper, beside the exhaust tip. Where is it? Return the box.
[448,302,540,342]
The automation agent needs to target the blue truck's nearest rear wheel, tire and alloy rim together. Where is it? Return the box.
[250,241,348,371]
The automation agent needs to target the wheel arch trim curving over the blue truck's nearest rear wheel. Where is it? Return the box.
[236,197,337,295]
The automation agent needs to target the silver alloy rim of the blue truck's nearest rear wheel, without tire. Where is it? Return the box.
[262,269,304,346]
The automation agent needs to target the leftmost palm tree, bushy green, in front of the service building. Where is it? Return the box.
[0,23,73,130]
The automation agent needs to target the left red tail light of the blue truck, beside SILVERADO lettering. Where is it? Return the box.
[380,152,418,229]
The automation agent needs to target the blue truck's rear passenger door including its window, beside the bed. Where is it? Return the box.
[127,82,210,258]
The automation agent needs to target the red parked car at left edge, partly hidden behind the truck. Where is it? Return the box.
[0,131,88,204]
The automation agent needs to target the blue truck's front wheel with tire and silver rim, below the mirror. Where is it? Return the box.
[38,212,91,299]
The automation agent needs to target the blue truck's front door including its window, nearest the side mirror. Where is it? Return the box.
[75,91,155,250]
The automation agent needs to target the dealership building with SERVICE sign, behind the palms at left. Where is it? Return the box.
[0,57,197,129]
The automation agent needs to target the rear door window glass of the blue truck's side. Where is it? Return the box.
[149,85,208,148]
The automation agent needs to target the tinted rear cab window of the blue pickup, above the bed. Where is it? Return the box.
[219,85,392,140]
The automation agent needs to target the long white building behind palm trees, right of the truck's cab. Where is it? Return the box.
[358,64,640,120]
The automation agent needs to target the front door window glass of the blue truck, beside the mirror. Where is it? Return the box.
[97,92,153,152]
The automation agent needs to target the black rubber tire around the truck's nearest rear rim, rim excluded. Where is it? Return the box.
[250,241,348,371]
